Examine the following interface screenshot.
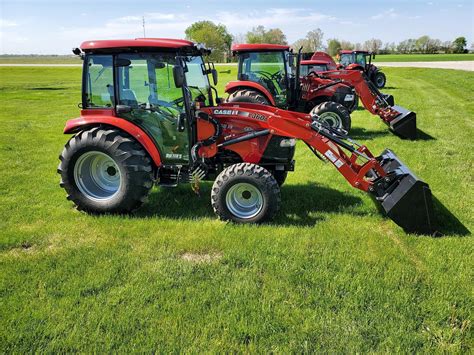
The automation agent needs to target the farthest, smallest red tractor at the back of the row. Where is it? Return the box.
[338,50,387,89]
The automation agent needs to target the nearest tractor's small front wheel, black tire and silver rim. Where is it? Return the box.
[211,163,281,223]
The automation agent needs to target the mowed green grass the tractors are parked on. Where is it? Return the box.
[0,67,474,353]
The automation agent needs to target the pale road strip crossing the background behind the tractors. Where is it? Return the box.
[0,60,474,71]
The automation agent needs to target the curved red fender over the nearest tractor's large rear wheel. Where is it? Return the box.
[64,110,161,166]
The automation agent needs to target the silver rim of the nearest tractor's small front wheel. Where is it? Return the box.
[226,182,263,219]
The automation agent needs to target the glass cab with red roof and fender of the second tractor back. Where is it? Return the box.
[226,44,299,108]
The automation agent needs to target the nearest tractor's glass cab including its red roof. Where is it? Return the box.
[78,38,217,164]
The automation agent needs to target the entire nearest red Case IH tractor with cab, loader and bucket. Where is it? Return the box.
[58,38,434,234]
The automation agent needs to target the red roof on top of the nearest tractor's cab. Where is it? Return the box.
[81,38,204,52]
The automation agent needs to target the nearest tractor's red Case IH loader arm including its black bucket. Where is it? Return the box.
[199,103,434,234]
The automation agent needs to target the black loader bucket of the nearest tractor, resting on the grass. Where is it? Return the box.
[374,149,436,235]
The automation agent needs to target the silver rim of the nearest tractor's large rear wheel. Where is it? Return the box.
[74,151,122,201]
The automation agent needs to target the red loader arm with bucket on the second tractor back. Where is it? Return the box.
[319,70,417,139]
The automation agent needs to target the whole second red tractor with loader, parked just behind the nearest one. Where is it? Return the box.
[225,44,417,139]
